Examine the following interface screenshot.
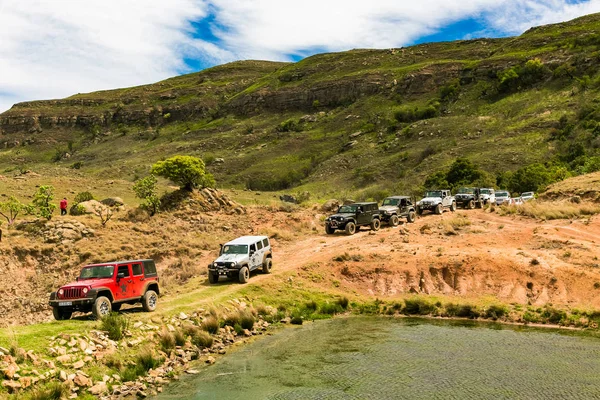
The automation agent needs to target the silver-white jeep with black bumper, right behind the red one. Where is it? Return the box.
[208,236,273,283]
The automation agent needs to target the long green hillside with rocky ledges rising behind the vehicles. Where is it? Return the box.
[0,14,600,197]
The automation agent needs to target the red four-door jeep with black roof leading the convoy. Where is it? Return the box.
[50,260,160,320]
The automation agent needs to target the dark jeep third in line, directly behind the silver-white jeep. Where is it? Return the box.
[325,202,381,235]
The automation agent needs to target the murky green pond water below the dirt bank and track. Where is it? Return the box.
[151,317,600,400]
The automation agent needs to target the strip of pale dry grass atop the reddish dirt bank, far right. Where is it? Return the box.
[500,201,600,220]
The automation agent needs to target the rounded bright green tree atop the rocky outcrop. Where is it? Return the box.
[150,156,215,191]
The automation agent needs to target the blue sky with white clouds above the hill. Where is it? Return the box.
[0,0,600,112]
